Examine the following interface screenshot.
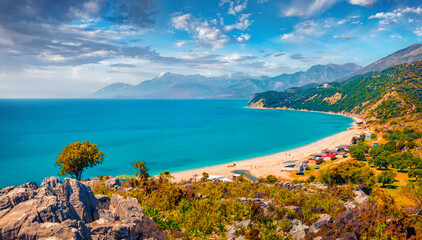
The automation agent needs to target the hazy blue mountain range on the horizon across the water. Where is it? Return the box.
[90,63,361,99]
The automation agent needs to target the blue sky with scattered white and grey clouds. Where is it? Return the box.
[0,0,422,98]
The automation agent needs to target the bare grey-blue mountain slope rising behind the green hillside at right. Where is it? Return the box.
[354,44,422,75]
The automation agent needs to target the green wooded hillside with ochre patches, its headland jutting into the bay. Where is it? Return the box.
[248,61,422,119]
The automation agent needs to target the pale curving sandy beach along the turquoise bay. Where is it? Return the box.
[172,110,363,181]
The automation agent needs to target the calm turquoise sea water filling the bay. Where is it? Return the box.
[0,99,352,187]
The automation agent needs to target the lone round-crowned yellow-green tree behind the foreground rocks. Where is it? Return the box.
[55,141,104,180]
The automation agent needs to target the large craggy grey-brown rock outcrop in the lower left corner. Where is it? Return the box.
[0,177,166,240]
